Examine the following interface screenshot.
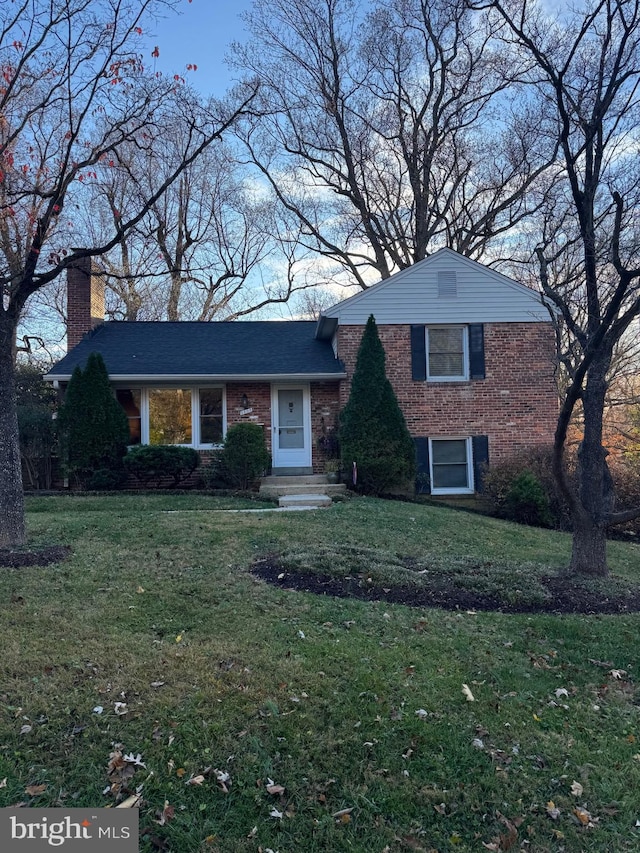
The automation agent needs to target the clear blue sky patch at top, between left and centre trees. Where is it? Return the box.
[144,0,251,97]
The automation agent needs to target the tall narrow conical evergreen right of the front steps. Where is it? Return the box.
[339,315,415,494]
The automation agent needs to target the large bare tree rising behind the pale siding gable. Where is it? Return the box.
[234,0,555,287]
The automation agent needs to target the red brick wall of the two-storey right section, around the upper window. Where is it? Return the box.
[338,323,558,462]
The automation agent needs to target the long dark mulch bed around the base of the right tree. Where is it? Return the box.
[251,559,640,615]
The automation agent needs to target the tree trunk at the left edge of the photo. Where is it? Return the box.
[0,310,25,548]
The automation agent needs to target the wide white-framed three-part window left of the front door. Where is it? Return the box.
[116,385,226,449]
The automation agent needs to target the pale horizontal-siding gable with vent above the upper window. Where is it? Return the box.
[316,248,550,338]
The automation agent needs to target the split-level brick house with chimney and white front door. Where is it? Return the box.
[47,249,558,494]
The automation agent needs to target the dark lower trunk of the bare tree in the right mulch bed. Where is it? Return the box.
[569,347,614,577]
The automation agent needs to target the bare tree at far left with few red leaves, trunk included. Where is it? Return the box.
[0,0,252,547]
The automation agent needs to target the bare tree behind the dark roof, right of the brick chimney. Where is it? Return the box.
[85,135,275,321]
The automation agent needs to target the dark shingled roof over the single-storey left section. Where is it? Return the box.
[47,321,345,382]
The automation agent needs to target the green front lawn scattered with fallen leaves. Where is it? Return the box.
[0,495,640,853]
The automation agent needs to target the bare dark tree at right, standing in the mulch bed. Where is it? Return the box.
[484,0,640,575]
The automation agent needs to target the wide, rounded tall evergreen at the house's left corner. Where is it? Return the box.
[58,353,129,488]
